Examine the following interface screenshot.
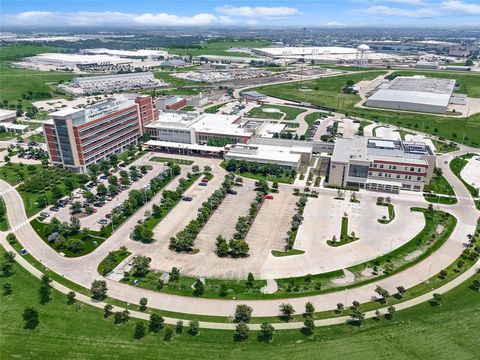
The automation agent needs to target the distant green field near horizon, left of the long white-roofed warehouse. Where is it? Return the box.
[167,39,270,57]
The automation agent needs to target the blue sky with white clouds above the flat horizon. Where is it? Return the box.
[0,0,480,30]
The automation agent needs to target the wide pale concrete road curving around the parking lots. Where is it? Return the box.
[0,148,480,316]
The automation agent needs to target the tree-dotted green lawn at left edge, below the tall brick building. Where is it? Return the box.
[0,163,88,217]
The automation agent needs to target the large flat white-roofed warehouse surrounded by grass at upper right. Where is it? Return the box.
[365,76,455,114]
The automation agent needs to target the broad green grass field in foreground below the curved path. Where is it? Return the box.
[0,245,480,360]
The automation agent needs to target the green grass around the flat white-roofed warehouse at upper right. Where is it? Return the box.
[251,71,480,147]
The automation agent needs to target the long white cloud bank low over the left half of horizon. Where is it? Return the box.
[1,11,235,27]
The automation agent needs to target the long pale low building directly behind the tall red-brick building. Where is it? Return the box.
[58,72,168,95]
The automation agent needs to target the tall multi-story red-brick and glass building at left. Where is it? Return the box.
[43,96,158,172]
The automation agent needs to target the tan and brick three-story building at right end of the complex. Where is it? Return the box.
[328,137,435,193]
